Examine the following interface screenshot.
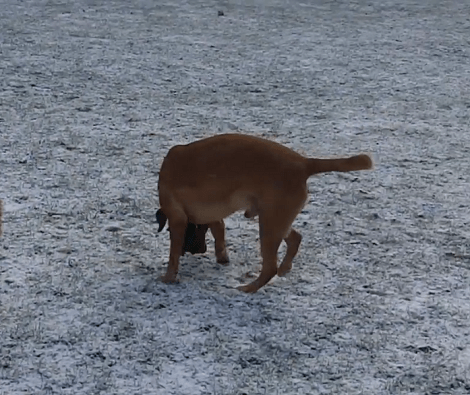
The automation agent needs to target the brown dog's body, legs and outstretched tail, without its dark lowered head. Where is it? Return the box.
[158,134,372,292]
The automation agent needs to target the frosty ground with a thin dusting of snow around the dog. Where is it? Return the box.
[0,0,470,395]
